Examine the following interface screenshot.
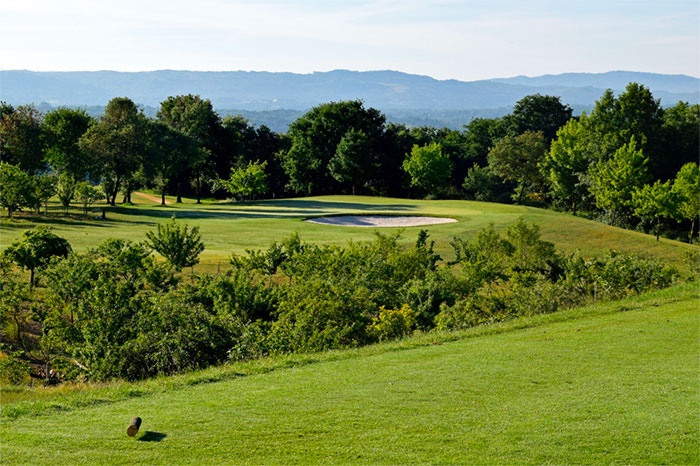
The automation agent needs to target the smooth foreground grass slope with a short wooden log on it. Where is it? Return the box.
[0,285,700,464]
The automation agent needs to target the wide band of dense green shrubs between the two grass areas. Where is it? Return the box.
[0,206,679,381]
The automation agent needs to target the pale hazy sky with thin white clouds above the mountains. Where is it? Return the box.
[0,0,700,80]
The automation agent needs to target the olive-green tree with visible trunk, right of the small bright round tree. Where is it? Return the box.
[488,131,547,204]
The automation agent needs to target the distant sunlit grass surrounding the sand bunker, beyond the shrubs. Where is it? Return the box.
[0,195,692,272]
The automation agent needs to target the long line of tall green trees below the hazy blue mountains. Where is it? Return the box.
[0,83,700,238]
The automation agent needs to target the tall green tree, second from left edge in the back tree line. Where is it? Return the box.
[41,107,95,180]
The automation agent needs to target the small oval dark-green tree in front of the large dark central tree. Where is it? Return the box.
[328,129,376,195]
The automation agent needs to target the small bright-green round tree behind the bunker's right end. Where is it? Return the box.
[403,143,452,194]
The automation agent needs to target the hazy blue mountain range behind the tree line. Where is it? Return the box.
[0,70,700,131]
